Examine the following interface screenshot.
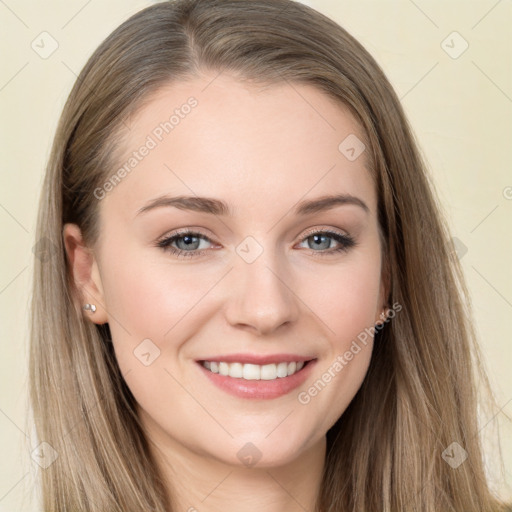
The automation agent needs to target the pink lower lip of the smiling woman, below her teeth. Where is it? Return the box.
[197,359,317,400]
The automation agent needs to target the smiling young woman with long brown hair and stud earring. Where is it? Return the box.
[30,0,505,512]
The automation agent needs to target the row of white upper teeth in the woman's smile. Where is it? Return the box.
[202,361,304,380]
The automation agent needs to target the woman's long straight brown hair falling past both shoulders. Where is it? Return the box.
[30,0,504,512]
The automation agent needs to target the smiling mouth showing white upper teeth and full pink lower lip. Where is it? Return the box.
[196,356,317,399]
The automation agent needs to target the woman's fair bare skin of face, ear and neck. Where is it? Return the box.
[63,73,387,512]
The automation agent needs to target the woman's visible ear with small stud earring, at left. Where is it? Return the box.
[62,223,108,324]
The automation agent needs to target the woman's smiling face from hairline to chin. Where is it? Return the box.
[66,73,385,466]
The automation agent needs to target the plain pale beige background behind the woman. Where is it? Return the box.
[0,0,512,512]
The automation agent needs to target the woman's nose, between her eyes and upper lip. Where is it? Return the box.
[226,250,299,336]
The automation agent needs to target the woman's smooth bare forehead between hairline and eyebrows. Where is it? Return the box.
[103,73,376,222]
